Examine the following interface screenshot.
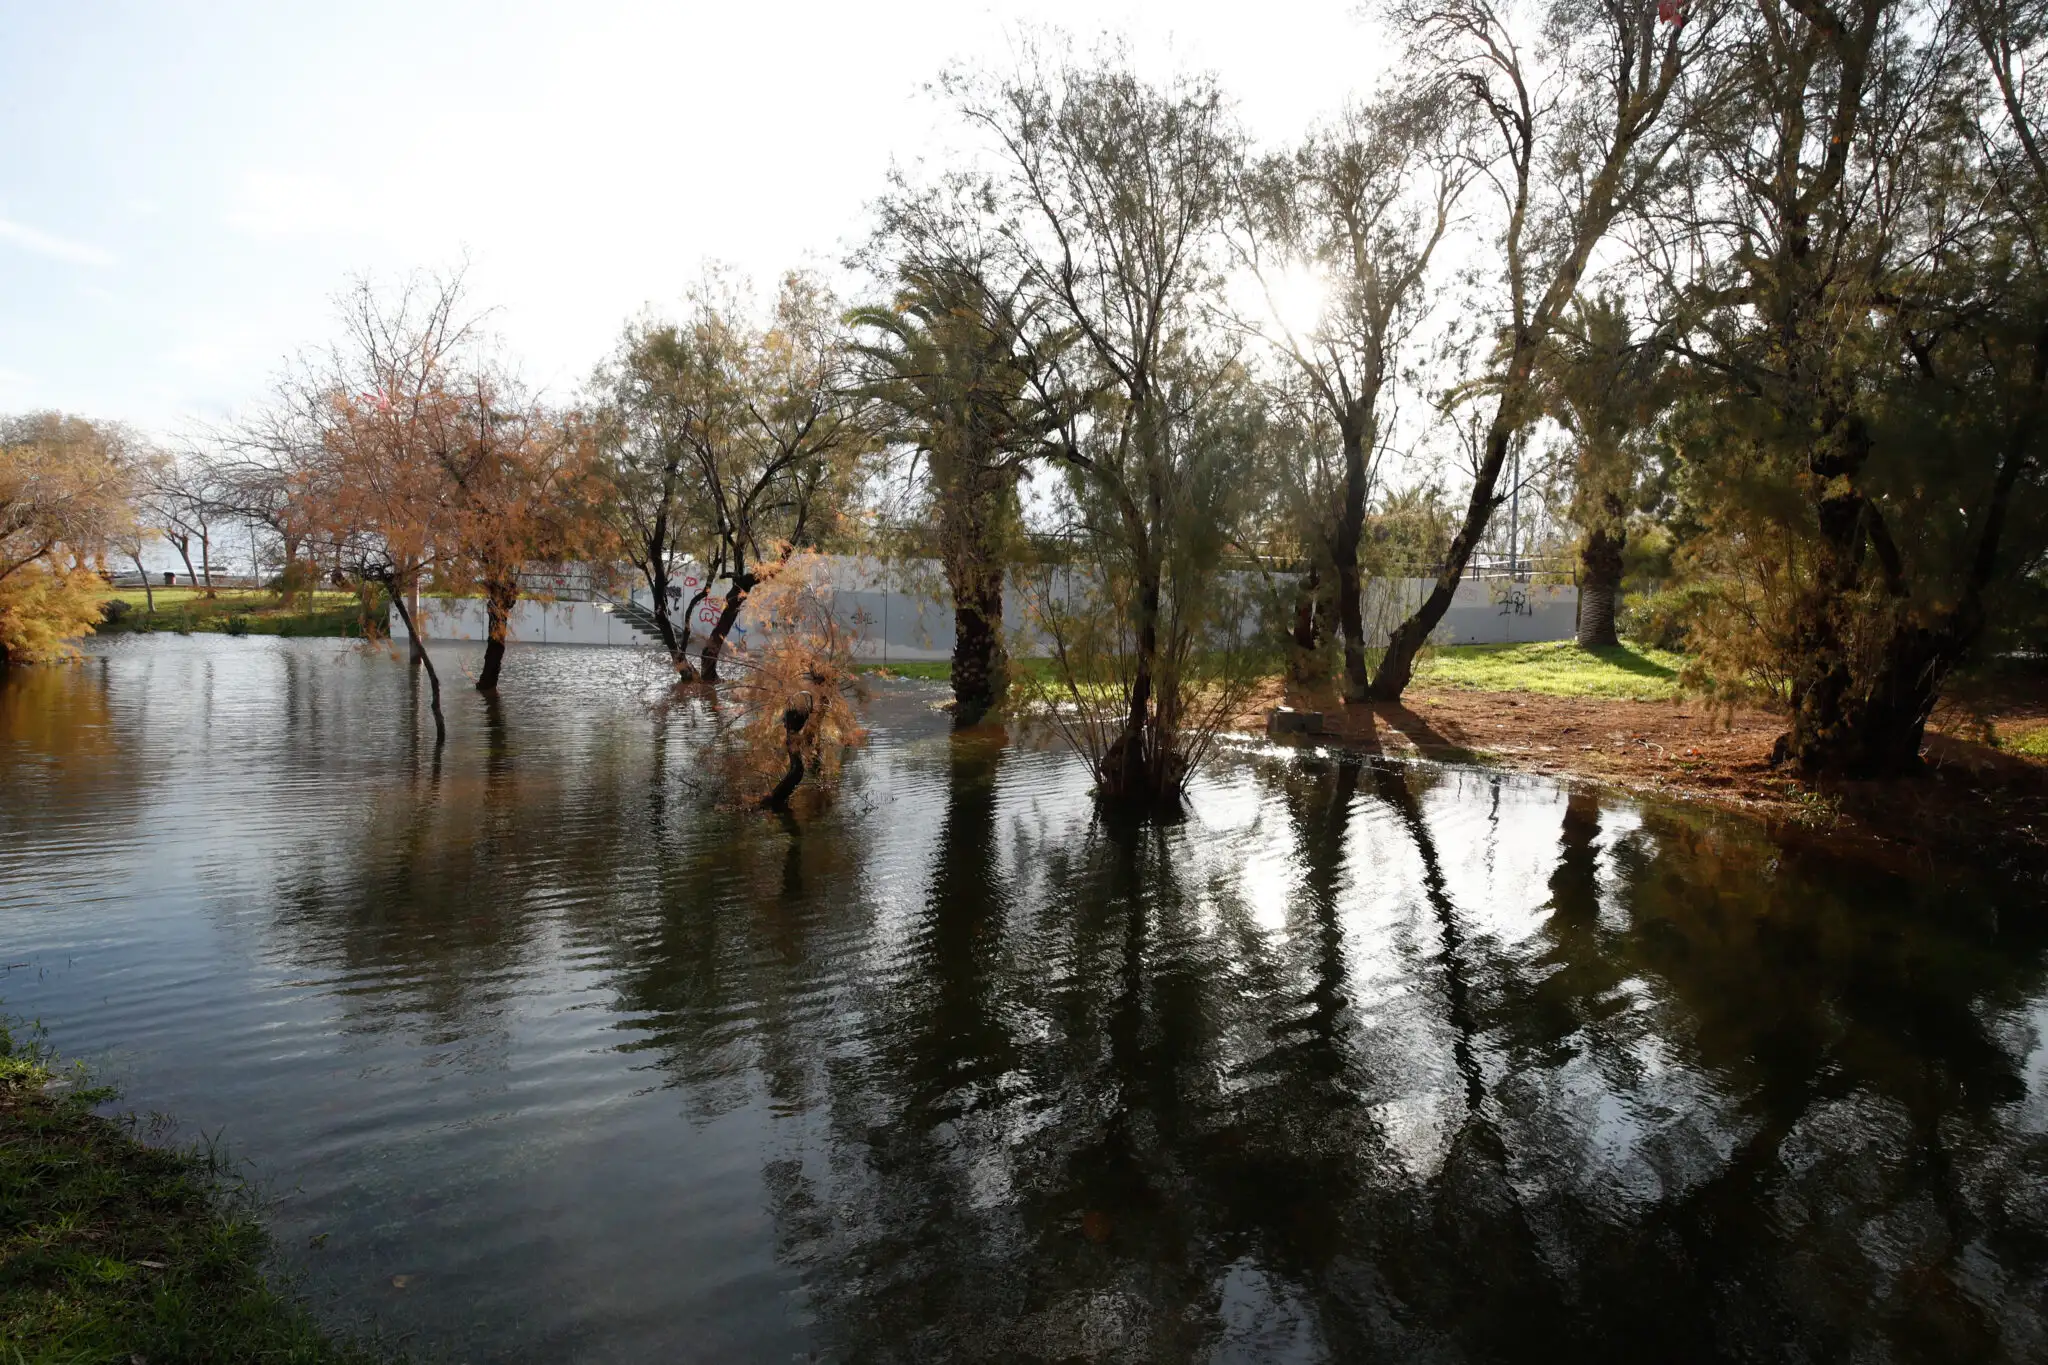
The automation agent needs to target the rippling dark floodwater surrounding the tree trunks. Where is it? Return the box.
[0,636,2048,1361]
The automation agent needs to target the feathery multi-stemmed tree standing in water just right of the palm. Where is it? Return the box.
[948,53,1247,804]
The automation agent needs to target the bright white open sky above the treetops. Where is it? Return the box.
[0,0,1389,434]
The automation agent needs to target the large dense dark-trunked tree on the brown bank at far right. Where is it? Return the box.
[1665,0,2048,776]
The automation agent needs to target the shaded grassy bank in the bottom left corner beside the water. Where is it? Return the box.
[0,1023,375,1365]
